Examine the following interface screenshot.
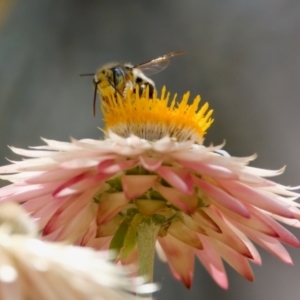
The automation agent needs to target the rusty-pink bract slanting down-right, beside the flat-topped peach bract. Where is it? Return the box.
[154,183,198,214]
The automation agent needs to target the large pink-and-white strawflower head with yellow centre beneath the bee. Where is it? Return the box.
[0,89,300,288]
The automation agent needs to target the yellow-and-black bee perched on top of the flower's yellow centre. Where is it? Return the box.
[80,51,185,116]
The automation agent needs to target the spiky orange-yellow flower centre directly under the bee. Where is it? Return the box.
[101,87,213,143]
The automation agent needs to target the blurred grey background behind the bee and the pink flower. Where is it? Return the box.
[0,0,300,300]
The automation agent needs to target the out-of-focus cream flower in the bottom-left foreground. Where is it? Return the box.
[0,203,157,300]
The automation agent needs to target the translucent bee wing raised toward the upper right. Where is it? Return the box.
[133,51,185,76]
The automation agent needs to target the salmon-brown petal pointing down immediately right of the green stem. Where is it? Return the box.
[158,234,195,288]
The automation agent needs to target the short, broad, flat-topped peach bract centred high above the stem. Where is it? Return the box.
[122,175,158,199]
